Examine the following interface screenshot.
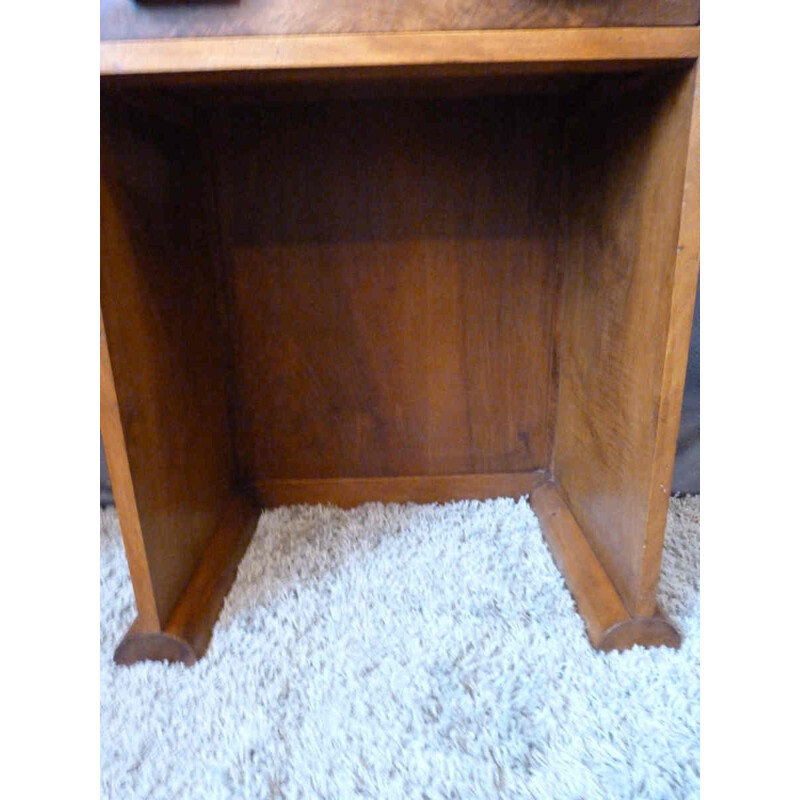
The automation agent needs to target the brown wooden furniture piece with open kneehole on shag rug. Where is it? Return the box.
[100,0,699,664]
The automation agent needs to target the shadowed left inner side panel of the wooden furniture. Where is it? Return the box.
[100,98,234,627]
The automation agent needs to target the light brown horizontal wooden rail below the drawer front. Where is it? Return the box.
[100,27,700,75]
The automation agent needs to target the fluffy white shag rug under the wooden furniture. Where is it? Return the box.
[100,497,700,800]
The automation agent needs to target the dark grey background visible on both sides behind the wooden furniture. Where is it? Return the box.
[100,289,700,505]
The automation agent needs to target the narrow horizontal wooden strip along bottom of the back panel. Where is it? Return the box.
[254,471,547,508]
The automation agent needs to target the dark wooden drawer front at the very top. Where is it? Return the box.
[100,0,700,39]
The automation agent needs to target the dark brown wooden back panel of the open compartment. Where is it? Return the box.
[215,98,560,481]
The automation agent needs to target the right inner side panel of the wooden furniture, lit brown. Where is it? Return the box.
[553,67,696,616]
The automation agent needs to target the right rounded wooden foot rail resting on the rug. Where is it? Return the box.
[530,481,680,650]
